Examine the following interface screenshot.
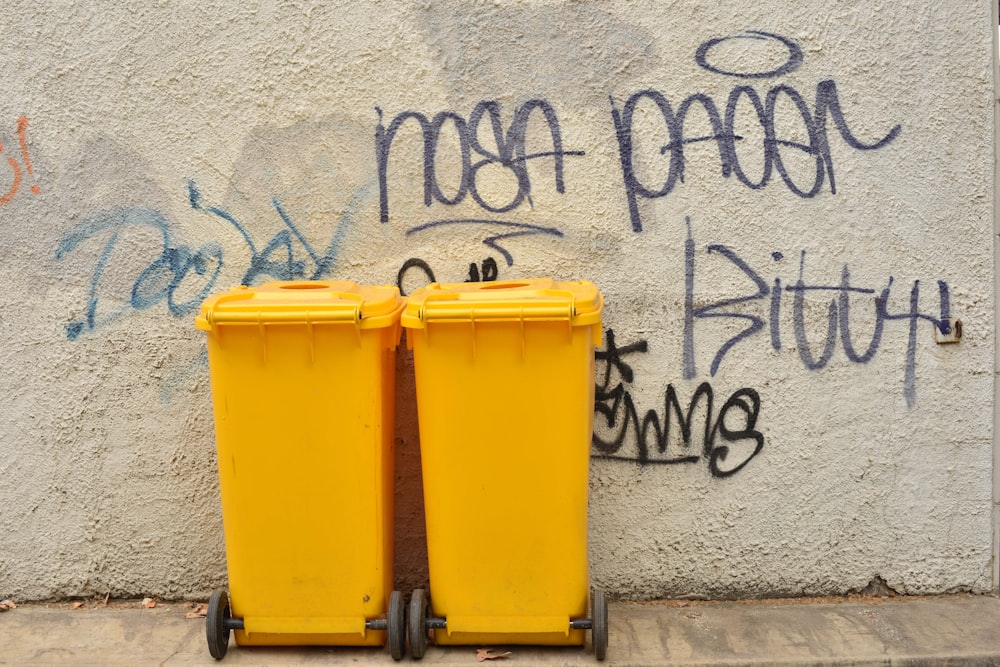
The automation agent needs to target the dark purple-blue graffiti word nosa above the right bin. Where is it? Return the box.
[375,99,584,222]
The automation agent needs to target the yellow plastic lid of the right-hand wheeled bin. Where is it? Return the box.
[401,278,604,329]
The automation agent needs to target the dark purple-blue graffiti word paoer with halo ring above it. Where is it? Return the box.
[608,33,902,232]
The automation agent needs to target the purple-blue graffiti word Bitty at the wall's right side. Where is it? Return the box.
[683,218,951,407]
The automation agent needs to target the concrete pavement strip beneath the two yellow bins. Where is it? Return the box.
[0,595,1000,667]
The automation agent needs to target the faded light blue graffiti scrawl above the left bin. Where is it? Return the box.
[56,181,371,340]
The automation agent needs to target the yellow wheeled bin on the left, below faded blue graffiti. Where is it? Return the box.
[196,281,406,660]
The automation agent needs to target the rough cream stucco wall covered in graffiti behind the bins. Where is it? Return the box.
[0,0,995,600]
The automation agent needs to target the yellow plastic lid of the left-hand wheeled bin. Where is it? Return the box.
[195,280,404,331]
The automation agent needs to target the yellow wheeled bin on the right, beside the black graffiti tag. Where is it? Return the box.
[401,279,607,659]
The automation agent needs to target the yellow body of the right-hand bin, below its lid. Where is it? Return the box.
[407,321,594,644]
